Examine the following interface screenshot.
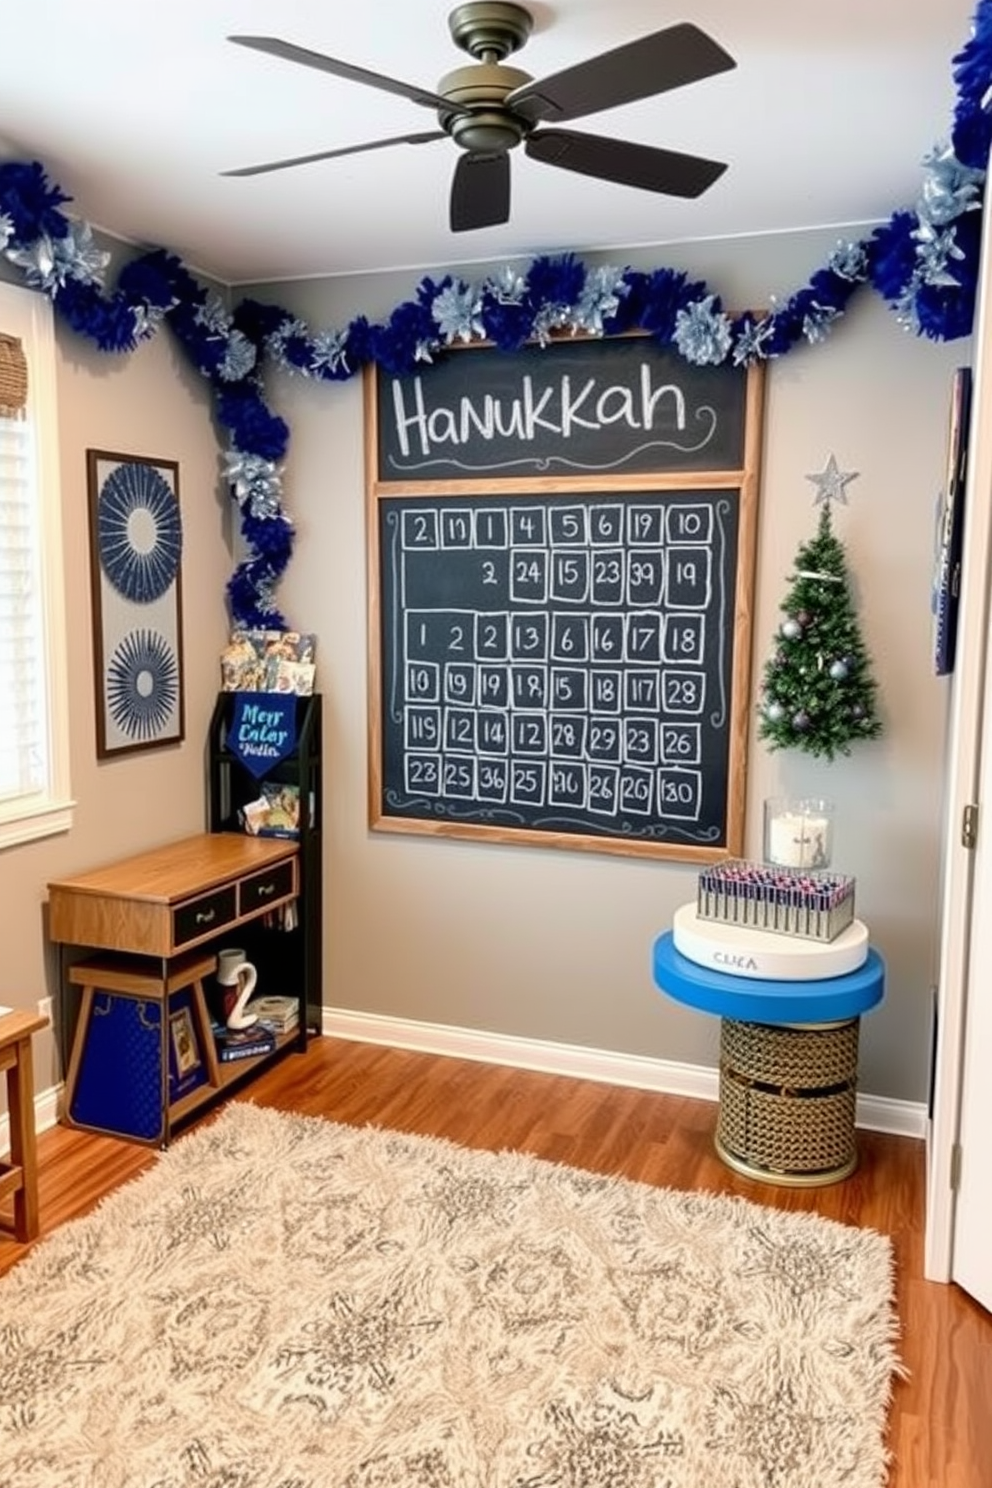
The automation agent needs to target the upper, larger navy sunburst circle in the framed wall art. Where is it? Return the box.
[97,464,183,604]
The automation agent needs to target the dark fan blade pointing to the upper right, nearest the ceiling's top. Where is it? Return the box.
[506,21,738,124]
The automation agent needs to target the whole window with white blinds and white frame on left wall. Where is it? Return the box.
[0,283,73,848]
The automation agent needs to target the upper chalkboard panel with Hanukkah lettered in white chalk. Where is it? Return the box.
[376,336,747,481]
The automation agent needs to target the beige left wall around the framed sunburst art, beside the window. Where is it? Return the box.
[0,319,231,1089]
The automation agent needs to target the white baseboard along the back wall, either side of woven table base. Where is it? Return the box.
[323,1007,927,1140]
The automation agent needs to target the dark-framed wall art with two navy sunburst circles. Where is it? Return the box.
[86,449,184,759]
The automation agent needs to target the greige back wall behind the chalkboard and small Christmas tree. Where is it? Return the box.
[254,220,970,1101]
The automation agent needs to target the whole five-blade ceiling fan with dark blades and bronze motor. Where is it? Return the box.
[222,0,736,232]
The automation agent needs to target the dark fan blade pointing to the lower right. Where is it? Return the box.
[524,129,727,196]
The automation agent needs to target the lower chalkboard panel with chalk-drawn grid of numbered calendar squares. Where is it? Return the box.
[376,493,730,841]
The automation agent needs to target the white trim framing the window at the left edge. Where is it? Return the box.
[0,283,74,850]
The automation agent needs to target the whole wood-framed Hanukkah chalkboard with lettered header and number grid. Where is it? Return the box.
[366,338,760,862]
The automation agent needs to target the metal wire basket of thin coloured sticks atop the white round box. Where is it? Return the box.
[696,859,855,940]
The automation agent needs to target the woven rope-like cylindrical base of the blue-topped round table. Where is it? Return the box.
[717,1018,858,1187]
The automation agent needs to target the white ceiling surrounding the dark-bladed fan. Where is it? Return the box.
[0,0,974,283]
